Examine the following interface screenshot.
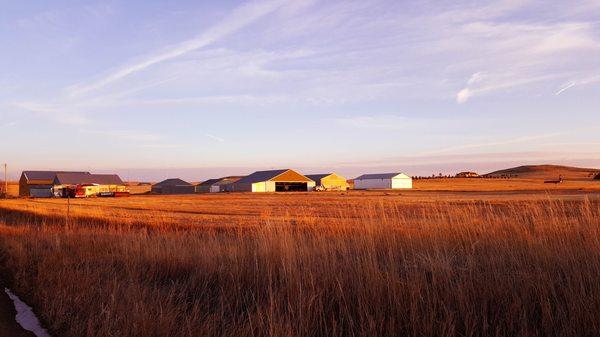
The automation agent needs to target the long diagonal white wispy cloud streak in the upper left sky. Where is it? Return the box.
[68,0,286,96]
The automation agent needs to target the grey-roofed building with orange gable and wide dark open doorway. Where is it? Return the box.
[231,169,315,192]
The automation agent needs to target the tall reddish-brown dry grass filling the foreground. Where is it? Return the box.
[0,200,600,336]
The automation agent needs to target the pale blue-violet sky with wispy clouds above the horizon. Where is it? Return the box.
[0,0,600,180]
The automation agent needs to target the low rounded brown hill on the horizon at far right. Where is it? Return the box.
[486,165,600,179]
